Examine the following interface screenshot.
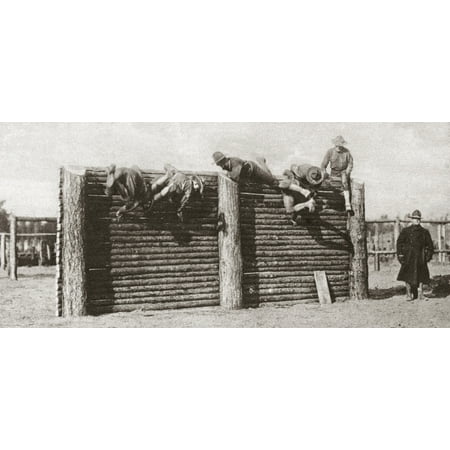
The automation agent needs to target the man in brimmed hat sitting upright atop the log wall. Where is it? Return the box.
[321,136,354,215]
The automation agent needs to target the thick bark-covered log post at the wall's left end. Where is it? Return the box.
[60,168,87,316]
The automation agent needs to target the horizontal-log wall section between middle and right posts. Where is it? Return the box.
[240,178,352,305]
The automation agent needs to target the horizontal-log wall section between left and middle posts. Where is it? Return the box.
[82,169,219,314]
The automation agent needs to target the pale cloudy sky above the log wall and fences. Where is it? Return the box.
[0,122,450,219]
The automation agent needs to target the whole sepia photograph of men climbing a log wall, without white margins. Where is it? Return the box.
[0,122,450,328]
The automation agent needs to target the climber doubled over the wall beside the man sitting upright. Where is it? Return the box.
[280,164,325,225]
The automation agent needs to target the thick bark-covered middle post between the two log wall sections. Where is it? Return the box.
[218,175,243,309]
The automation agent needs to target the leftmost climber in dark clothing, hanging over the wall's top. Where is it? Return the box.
[105,164,152,220]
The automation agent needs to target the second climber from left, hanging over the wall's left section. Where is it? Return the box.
[151,164,204,222]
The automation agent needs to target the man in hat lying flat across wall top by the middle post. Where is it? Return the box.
[213,152,278,186]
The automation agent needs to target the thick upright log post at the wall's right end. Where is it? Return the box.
[349,180,369,300]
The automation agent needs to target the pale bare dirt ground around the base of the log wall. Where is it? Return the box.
[0,263,450,328]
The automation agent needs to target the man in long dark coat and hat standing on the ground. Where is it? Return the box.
[397,210,434,301]
